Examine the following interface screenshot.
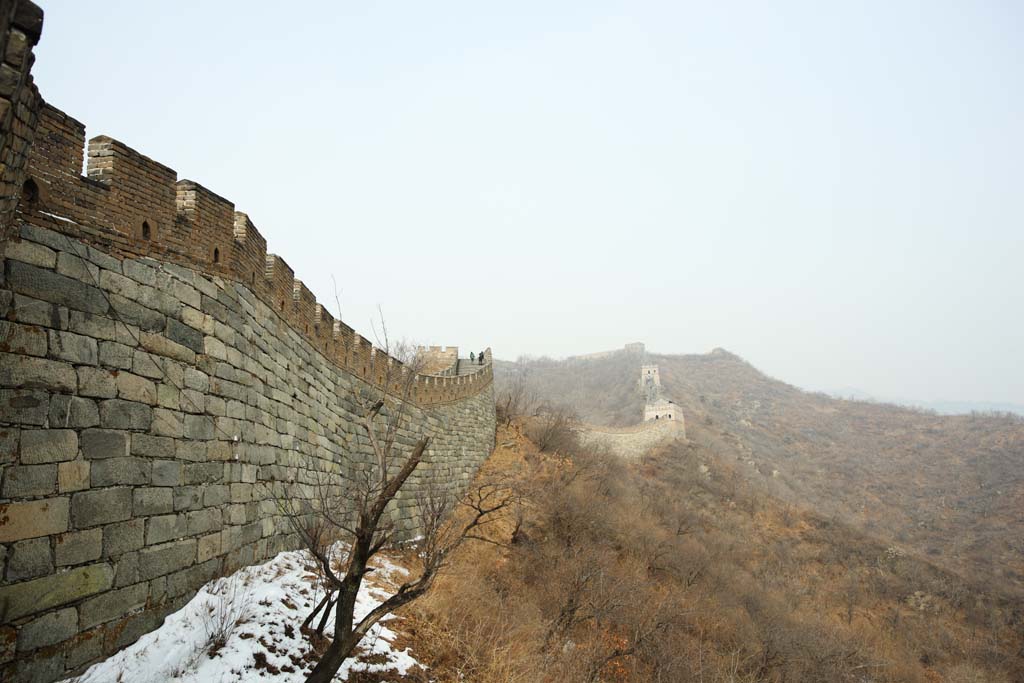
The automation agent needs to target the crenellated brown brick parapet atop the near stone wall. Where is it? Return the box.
[16,103,493,404]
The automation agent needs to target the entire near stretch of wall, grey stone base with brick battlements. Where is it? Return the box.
[0,0,496,683]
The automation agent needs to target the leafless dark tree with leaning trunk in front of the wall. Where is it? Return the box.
[273,321,514,683]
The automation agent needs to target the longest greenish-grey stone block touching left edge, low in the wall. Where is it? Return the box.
[0,564,114,622]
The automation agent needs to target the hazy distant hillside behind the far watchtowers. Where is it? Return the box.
[496,349,1024,597]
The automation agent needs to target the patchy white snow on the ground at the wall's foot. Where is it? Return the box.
[71,547,422,683]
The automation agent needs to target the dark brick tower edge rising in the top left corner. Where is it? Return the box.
[0,0,43,239]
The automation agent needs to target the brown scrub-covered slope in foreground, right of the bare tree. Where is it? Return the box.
[395,424,1024,683]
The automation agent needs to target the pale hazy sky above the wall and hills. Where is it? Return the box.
[35,0,1024,402]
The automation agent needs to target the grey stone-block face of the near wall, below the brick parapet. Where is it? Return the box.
[0,222,495,681]
